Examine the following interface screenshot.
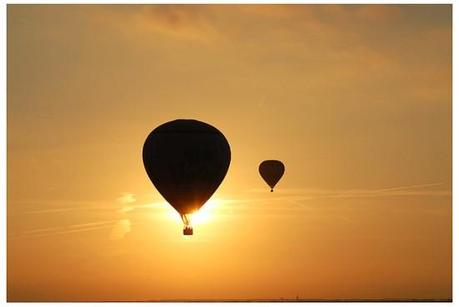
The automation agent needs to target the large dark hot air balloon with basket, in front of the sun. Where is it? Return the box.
[143,119,231,235]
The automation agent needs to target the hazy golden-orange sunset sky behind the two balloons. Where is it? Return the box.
[7,4,452,301]
